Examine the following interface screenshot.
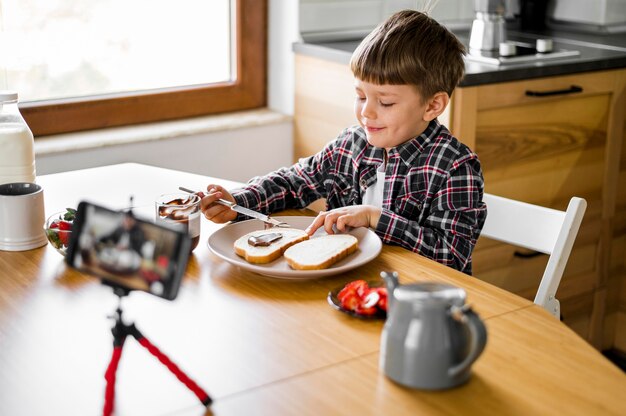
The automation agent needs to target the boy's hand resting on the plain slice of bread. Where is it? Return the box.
[305,205,382,236]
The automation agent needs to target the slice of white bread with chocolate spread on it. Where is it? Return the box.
[234,228,309,264]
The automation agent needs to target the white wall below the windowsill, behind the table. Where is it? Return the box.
[35,119,293,186]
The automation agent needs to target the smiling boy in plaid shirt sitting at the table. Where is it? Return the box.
[202,10,486,274]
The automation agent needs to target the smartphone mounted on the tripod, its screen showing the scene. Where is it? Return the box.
[65,202,191,300]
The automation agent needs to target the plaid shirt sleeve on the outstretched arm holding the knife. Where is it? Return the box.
[231,131,345,219]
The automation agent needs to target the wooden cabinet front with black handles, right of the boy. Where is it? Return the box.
[451,71,624,348]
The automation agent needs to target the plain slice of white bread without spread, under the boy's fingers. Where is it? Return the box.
[285,234,359,270]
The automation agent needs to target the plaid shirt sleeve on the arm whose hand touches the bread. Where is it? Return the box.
[376,157,487,274]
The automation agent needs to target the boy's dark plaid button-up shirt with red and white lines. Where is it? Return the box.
[232,120,487,274]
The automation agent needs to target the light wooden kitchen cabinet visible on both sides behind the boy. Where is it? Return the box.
[294,55,626,351]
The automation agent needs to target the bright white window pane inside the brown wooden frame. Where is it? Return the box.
[0,0,236,102]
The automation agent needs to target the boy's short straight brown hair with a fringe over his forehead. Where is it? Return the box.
[350,10,465,100]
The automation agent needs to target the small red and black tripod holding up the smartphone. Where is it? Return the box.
[103,287,212,416]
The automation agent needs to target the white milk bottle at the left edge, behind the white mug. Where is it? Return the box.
[0,90,35,184]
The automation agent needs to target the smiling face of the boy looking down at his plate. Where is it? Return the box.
[354,78,434,150]
